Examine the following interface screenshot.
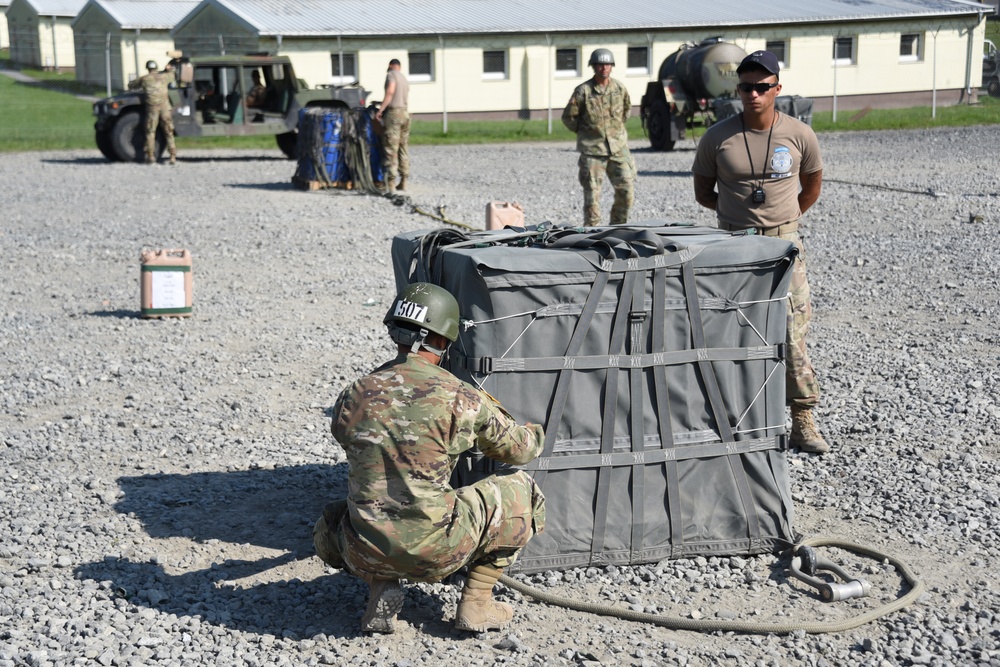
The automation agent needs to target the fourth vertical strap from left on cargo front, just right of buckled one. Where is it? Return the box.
[651,269,684,553]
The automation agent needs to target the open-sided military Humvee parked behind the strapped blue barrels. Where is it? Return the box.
[94,55,368,162]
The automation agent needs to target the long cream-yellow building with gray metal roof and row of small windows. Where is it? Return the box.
[164,0,993,118]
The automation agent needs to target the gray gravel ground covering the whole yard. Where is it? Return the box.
[0,127,1000,667]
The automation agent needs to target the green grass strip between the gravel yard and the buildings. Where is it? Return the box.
[0,45,1000,152]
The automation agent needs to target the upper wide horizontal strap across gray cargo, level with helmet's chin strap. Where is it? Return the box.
[457,344,784,375]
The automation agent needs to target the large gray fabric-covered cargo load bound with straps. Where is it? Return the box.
[392,221,796,572]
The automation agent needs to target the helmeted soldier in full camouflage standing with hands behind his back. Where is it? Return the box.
[562,49,636,227]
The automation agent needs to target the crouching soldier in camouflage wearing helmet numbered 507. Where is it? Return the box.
[313,283,545,632]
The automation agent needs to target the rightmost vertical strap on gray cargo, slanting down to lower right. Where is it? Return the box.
[682,264,760,545]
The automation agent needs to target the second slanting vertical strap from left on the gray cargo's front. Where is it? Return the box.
[590,272,643,559]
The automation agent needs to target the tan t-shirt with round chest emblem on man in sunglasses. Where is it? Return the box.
[691,113,823,229]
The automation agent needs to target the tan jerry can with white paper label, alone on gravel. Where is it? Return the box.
[139,250,192,317]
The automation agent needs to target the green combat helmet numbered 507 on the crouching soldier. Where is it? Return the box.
[382,283,458,354]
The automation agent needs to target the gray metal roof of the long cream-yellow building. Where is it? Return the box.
[178,0,992,36]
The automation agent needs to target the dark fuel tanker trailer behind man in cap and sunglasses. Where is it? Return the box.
[639,37,812,151]
